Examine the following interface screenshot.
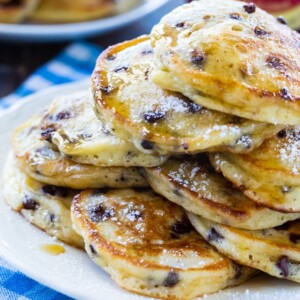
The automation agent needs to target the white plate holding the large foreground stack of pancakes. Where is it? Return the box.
[0,81,300,300]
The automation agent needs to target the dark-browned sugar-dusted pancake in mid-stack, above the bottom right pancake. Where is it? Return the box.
[145,155,300,230]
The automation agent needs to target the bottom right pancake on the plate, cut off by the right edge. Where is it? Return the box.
[188,213,300,282]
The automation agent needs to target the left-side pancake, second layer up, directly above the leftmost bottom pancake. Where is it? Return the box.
[11,117,147,189]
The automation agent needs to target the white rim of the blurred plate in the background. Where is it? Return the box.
[0,0,170,42]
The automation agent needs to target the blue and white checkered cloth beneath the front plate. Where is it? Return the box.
[0,42,101,300]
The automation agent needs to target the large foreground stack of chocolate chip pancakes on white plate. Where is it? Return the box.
[5,0,300,299]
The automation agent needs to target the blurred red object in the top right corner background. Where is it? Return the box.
[246,0,300,12]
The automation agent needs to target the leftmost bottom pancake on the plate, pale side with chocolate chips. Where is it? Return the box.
[3,153,83,248]
